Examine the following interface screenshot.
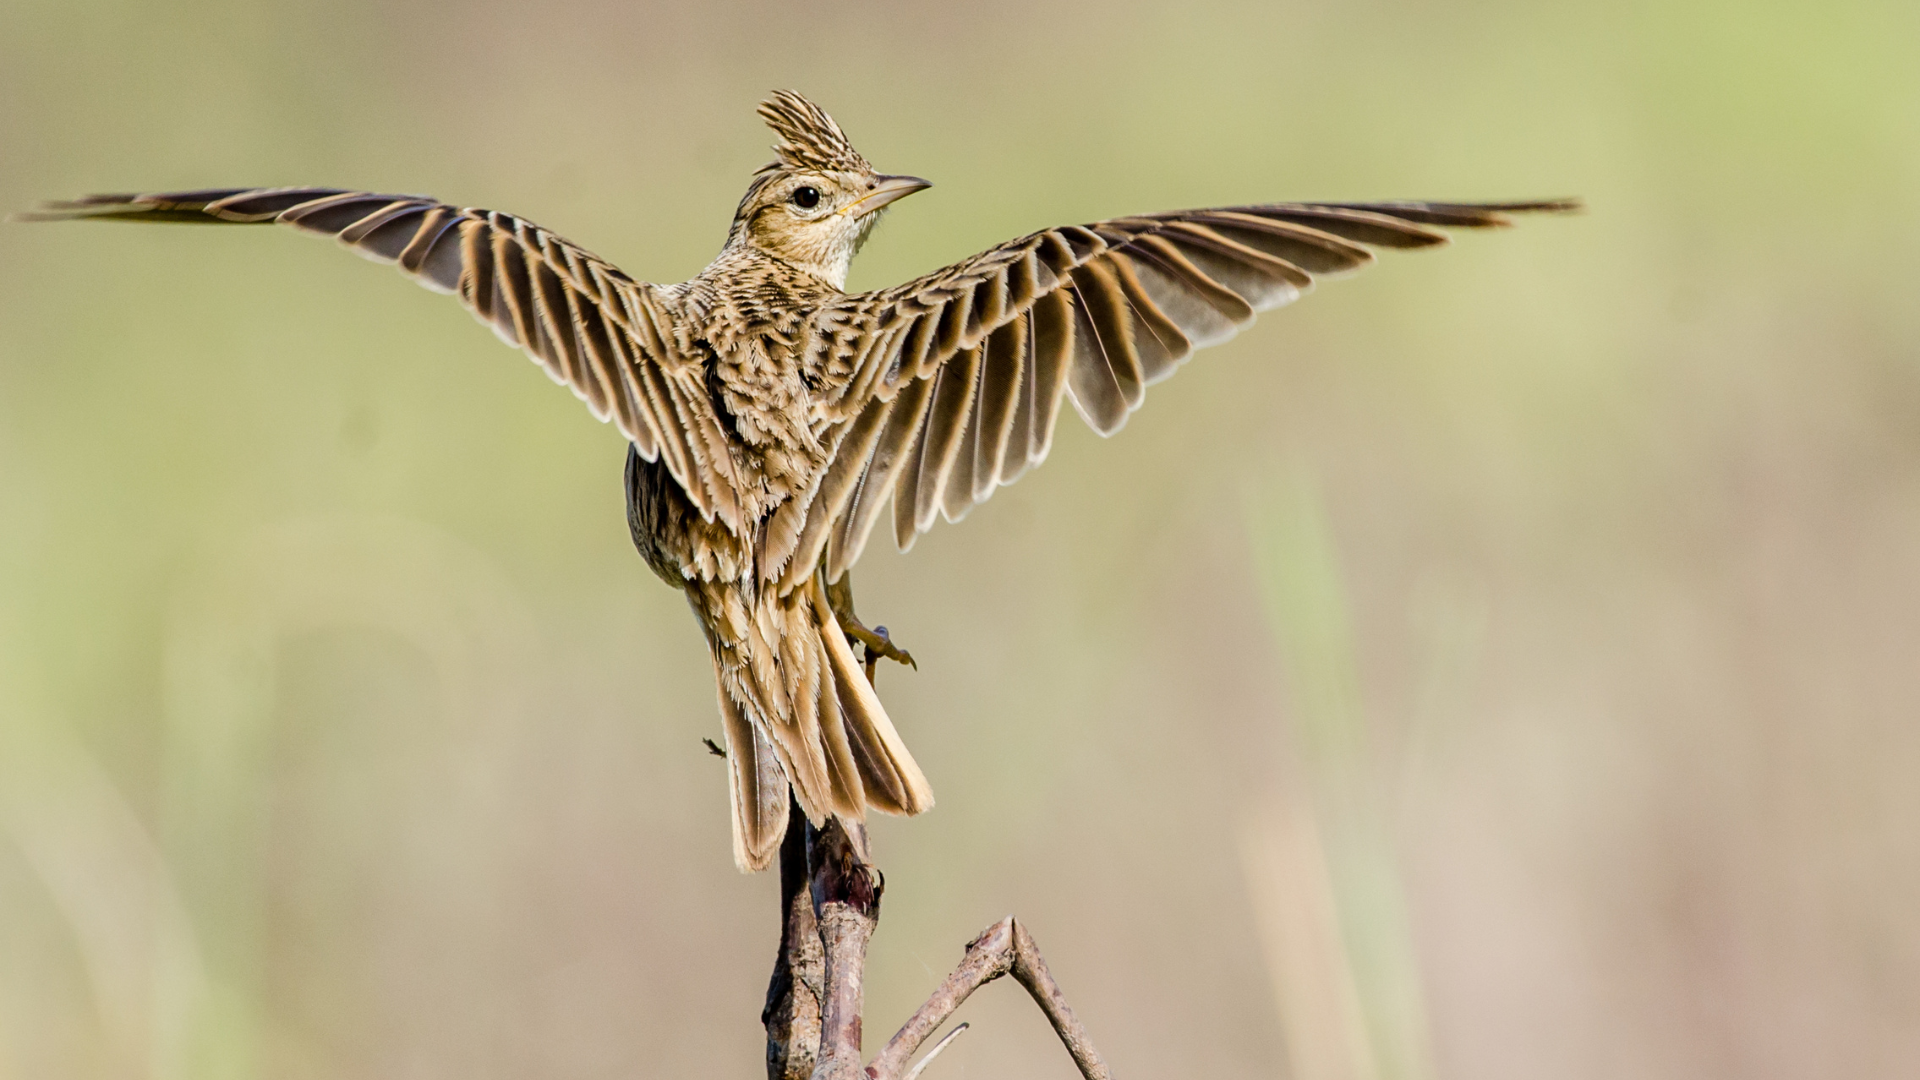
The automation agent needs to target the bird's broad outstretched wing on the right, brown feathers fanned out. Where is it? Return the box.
[789,193,1576,580]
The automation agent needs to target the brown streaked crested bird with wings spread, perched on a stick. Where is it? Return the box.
[21,90,1578,871]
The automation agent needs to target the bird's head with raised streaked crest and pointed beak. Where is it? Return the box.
[728,90,933,288]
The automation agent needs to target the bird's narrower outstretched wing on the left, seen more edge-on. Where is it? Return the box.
[25,188,726,517]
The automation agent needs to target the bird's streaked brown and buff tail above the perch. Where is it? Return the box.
[714,577,933,871]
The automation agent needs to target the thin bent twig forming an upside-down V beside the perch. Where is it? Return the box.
[868,915,1114,1080]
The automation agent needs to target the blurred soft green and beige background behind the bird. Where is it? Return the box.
[0,0,1920,1080]
